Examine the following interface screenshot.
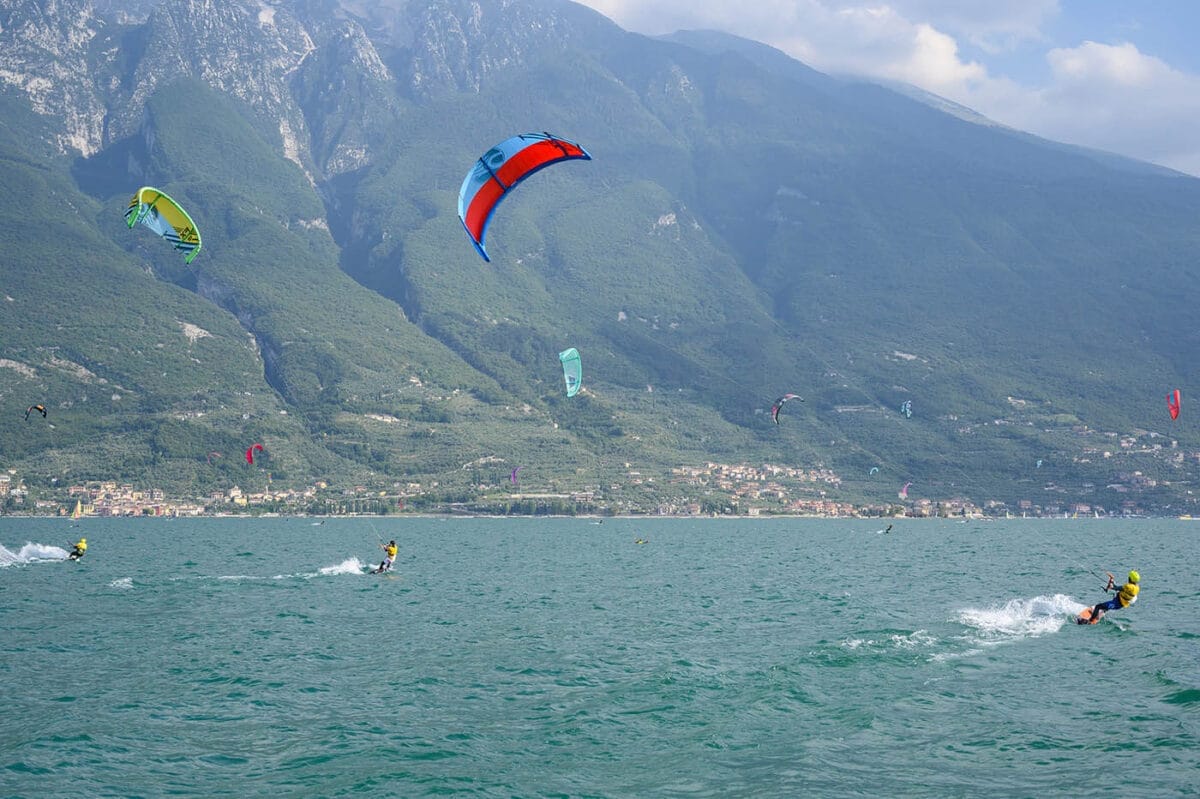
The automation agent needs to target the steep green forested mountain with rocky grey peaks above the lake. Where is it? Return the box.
[0,0,1200,512]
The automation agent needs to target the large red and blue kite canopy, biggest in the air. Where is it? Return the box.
[458,133,592,260]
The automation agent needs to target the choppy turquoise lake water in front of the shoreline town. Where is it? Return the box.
[0,518,1200,799]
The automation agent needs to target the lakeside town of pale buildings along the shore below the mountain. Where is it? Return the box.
[0,451,1176,518]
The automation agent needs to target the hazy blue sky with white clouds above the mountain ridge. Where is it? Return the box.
[578,0,1200,175]
